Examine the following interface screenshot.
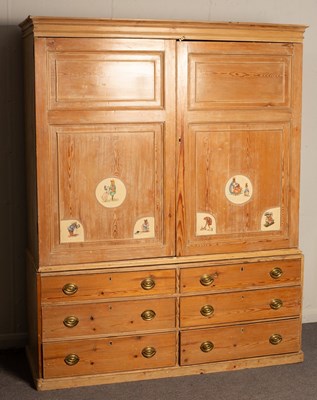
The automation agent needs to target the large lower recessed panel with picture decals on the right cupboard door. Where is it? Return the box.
[190,124,289,236]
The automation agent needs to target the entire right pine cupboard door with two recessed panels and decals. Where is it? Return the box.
[177,41,301,255]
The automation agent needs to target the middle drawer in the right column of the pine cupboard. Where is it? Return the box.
[180,286,301,327]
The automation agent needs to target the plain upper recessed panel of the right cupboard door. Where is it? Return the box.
[188,43,291,110]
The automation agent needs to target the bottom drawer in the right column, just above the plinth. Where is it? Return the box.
[180,319,301,365]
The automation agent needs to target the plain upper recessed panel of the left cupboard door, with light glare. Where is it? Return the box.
[48,39,164,110]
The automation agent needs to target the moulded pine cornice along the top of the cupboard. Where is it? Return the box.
[20,16,307,43]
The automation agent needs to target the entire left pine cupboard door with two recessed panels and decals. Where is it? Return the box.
[37,38,175,265]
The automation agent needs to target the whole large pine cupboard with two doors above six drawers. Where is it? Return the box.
[21,17,306,390]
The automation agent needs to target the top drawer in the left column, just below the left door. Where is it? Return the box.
[41,269,175,303]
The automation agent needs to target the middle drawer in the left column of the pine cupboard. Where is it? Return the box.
[42,298,175,341]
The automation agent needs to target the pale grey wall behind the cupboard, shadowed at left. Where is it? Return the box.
[0,0,317,347]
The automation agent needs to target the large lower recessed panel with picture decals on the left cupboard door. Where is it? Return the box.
[51,123,174,259]
